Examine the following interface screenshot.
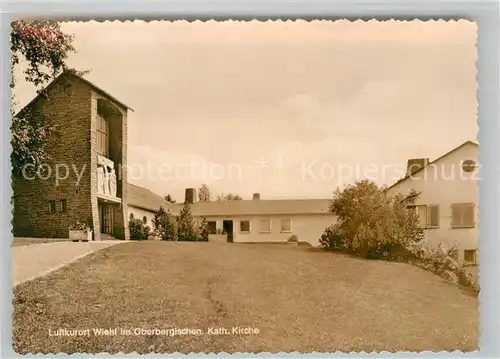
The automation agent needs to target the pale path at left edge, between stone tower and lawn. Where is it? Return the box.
[12,241,123,286]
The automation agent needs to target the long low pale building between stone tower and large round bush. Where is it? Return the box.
[128,184,335,246]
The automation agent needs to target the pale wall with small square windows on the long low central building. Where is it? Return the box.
[195,214,335,246]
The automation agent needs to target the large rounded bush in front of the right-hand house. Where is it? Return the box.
[321,180,423,258]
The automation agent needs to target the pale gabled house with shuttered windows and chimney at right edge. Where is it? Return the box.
[388,141,479,264]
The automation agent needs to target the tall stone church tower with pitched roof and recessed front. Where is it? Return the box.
[12,72,130,240]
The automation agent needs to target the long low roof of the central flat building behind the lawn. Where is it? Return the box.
[166,199,330,217]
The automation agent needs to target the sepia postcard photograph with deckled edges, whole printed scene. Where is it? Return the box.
[9,20,481,355]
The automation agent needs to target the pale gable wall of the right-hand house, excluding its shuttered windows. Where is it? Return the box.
[388,144,479,260]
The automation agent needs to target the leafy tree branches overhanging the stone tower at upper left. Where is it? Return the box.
[10,20,84,175]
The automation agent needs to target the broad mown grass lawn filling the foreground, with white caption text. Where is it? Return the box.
[13,241,478,354]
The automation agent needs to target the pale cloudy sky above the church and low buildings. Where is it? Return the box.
[16,20,478,200]
